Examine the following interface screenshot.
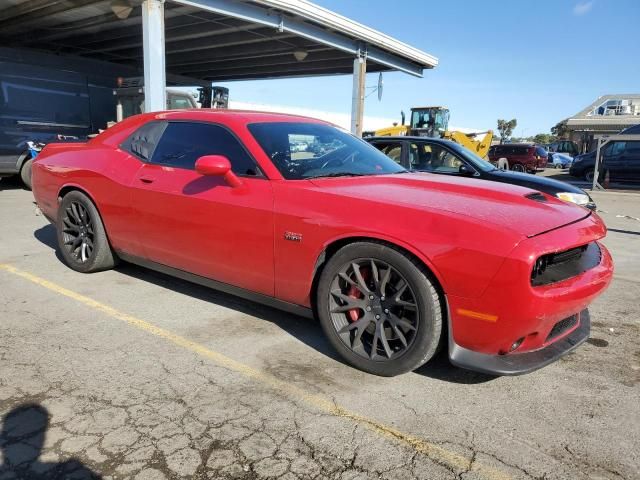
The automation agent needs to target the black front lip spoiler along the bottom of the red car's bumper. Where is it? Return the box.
[449,309,591,375]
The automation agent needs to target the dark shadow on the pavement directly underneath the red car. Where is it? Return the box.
[34,224,496,384]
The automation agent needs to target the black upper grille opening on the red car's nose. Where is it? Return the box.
[531,242,601,287]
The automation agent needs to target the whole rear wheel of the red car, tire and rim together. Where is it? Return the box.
[56,191,117,273]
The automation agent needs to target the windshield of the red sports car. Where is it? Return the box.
[248,122,406,180]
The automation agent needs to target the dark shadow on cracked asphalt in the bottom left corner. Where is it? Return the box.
[0,403,102,480]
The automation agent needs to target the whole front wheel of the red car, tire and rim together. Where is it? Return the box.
[316,242,443,377]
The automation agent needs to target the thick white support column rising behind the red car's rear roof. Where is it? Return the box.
[142,0,167,112]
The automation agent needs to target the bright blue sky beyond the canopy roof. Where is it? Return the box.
[223,0,640,137]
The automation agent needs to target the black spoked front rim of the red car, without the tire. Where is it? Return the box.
[329,258,419,361]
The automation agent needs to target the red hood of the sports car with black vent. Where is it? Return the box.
[310,173,591,237]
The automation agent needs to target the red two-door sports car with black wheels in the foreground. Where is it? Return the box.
[33,110,613,375]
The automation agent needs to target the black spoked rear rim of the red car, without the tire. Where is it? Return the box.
[62,202,95,263]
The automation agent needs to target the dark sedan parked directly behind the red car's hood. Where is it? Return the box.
[365,137,596,210]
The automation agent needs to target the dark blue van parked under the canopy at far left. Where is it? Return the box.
[0,47,118,188]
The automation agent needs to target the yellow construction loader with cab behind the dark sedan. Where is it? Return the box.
[365,107,493,157]
